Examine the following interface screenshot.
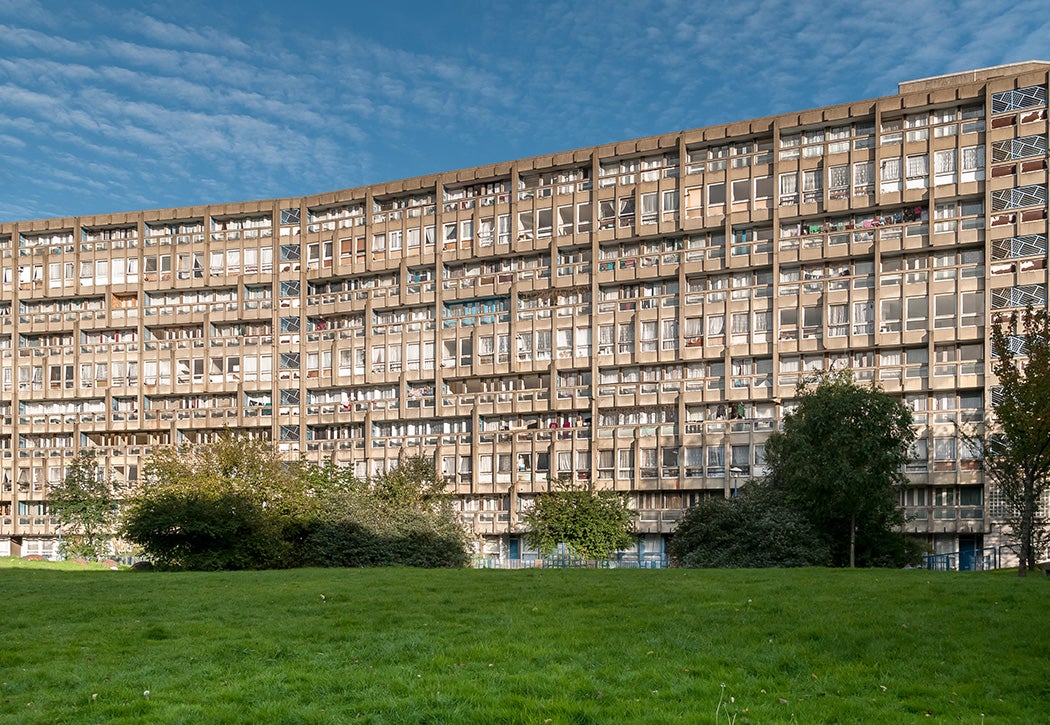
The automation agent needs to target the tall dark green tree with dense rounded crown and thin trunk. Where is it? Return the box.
[765,371,916,566]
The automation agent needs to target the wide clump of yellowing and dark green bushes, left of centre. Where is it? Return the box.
[123,436,468,569]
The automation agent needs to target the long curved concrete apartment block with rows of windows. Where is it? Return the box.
[0,62,1050,558]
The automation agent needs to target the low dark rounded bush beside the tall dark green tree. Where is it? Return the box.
[668,480,832,568]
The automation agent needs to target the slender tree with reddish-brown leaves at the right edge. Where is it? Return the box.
[982,308,1050,577]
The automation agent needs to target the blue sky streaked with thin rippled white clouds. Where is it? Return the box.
[0,0,1050,221]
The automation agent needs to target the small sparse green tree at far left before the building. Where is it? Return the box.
[47,449,119,559]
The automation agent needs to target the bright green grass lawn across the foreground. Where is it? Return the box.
[0,565,1050,724]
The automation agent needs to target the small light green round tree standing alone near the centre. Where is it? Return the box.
[523,480,634,559]
